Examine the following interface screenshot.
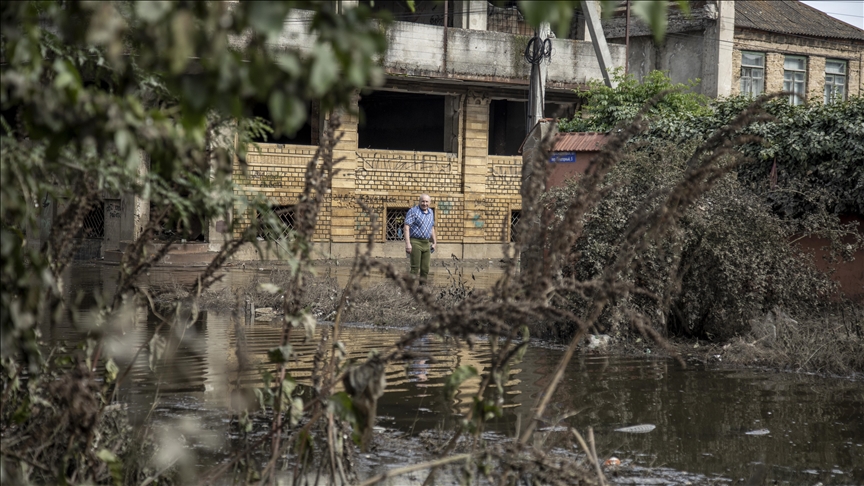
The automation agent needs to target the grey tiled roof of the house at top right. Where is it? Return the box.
[735,0,864,40]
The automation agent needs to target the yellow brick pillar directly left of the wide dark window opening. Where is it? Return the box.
[328,95,360,252]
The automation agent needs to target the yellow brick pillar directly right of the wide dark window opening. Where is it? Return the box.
[462,93,489,258]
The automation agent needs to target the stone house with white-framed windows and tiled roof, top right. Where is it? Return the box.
[604,0,864,100]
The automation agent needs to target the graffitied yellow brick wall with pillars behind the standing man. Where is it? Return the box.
[234,93,522,249]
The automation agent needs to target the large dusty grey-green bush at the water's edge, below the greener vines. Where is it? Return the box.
[547,144,834,340]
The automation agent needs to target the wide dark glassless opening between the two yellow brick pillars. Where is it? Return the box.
[357,91,447,152]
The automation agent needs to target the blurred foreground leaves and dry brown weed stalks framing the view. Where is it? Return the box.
[0,0,856,484]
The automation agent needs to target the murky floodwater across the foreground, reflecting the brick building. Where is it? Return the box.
[50,267,864,485]
